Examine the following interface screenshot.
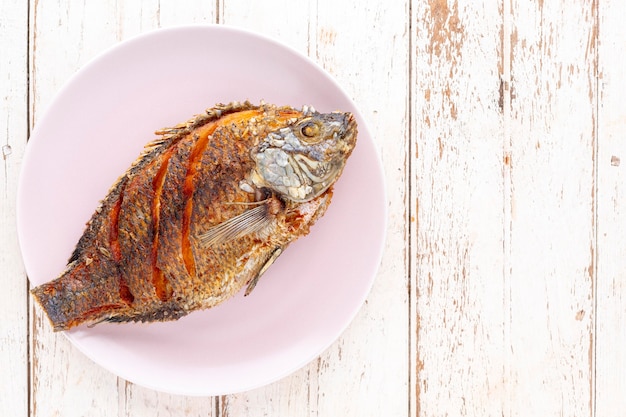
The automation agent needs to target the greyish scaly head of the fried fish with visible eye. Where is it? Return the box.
[251,108,357,202]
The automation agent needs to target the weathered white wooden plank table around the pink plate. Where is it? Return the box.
[0,0,626,417]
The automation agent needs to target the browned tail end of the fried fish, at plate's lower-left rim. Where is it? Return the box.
[31,267,132,331]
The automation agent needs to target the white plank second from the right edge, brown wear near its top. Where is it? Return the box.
[505,0,597,416]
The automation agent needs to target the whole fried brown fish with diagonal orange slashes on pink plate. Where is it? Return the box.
[32,102,357,331]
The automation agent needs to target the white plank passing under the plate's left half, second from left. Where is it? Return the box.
[31,0,215,416]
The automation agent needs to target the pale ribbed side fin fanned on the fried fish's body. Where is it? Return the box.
[200,204,272,246]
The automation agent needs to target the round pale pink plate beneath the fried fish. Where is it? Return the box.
[18,26,385,395]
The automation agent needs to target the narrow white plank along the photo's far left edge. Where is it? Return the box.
[0,2,28,416]
